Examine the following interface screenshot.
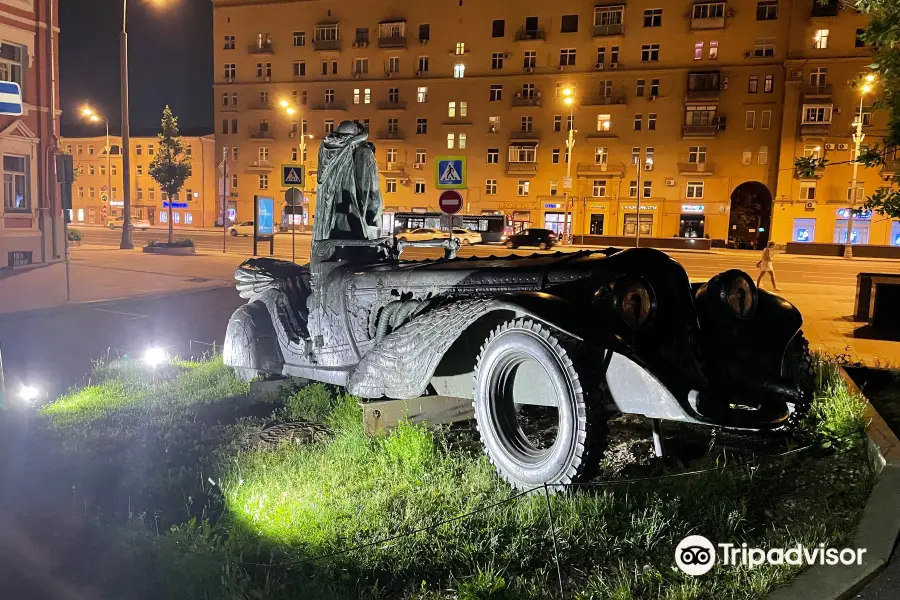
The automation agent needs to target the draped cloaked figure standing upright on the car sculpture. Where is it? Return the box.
[313,121,382,241]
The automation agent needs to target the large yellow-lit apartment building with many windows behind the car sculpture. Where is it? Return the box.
[214,0,900,243]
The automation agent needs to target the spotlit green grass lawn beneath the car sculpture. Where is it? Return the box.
[26,360,873,600]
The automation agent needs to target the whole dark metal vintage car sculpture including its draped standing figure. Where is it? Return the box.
[224,123,813,489]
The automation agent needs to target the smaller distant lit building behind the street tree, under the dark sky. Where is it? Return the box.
[62,134,222,228]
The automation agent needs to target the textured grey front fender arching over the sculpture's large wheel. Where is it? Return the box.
[347,292,631,399]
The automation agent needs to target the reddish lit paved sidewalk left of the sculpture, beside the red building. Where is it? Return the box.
[0,246,244,314]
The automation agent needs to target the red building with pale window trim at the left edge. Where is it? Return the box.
[0,0,65,268]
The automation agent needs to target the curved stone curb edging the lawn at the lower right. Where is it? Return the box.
[766,367,900,600]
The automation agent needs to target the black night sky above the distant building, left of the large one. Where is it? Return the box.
[59,0,213,136]
